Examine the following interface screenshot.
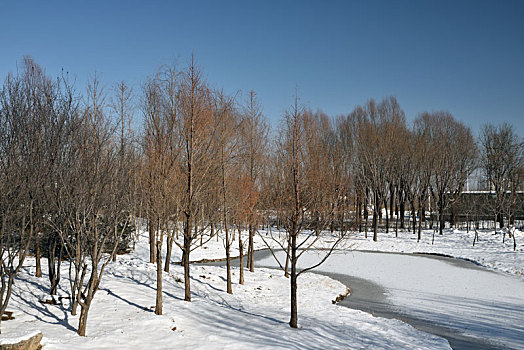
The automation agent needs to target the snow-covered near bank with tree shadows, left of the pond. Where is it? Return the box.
[1,231,449,349]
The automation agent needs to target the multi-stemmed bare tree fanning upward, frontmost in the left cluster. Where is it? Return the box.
[55,75,132,336]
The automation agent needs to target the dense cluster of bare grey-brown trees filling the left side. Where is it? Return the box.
[0,58,135,335]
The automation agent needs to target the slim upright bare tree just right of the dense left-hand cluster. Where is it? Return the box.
[143,68,180,315]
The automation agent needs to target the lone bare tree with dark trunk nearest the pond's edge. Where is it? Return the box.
[266,96,344,328]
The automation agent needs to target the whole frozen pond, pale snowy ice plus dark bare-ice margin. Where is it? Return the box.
[251,251,524,349]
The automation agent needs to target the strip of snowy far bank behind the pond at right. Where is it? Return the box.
[350,229,524,275]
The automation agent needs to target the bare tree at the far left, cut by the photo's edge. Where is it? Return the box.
[0,60,42,334]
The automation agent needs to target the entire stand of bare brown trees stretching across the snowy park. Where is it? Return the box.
[0,58,524,335]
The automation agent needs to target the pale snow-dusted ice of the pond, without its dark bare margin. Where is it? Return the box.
[259,251,524,349]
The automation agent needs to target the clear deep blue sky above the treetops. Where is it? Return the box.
[0,0,524,136]
